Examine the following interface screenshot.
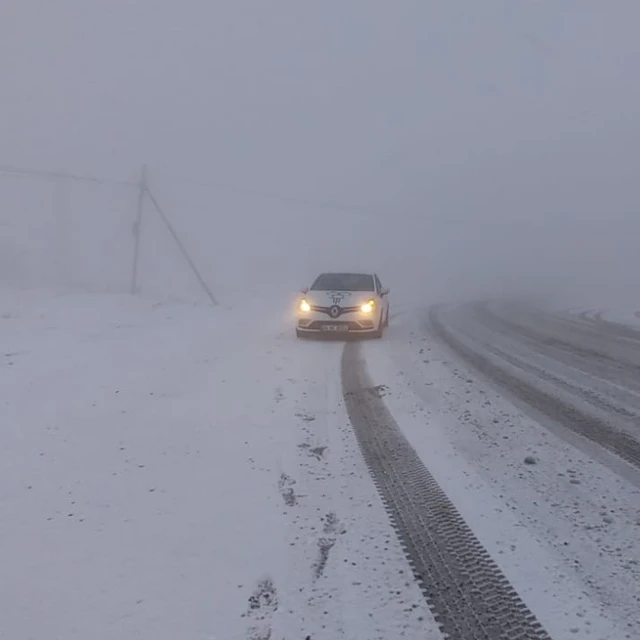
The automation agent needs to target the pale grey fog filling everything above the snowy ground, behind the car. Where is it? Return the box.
[0,0,640,303]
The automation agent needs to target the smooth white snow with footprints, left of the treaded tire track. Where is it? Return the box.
[0,292,439,640]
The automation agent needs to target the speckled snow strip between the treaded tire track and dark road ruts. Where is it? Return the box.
[366,312,640,640]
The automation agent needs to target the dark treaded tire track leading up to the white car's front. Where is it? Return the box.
[342,343,549,640]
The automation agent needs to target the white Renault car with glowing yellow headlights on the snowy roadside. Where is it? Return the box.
[296,273,389,338]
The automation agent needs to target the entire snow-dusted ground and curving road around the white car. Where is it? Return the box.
[0,292,640,640]
